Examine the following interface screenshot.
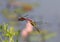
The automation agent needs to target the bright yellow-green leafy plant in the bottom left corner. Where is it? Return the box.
[0,24,20,42]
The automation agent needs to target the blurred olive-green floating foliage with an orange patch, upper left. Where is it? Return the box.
[1,0,39,26]
